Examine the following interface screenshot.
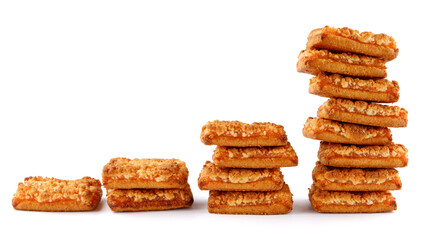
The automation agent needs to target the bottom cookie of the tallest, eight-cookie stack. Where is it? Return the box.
[309,185,397,213]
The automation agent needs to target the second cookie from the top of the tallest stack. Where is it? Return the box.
[297,49,387,78]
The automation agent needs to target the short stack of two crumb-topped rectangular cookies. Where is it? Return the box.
[102,158,193,212]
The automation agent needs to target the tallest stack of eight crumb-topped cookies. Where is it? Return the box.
[297,26,408,212]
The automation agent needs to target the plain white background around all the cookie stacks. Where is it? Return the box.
[0,0,432,239]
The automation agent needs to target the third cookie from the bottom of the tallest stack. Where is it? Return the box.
[318,142,408,168]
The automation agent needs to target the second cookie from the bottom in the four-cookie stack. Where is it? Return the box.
[198,161,284,191]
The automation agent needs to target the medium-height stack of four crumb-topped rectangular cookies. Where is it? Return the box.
[198,121,298,214]
